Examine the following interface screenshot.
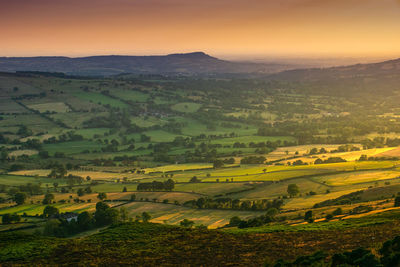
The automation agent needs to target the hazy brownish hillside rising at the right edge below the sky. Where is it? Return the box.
[267,59,400,97]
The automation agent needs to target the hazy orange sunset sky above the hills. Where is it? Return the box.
[0,0,400,57]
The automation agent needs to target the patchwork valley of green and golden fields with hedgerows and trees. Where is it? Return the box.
[0,70,400,266]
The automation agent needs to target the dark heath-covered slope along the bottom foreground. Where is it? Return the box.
[0,221,400,266]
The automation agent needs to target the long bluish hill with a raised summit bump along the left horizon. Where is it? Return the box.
[0,52,289,75]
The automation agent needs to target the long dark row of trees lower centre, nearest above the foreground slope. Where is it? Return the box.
[184,198,283,211]
